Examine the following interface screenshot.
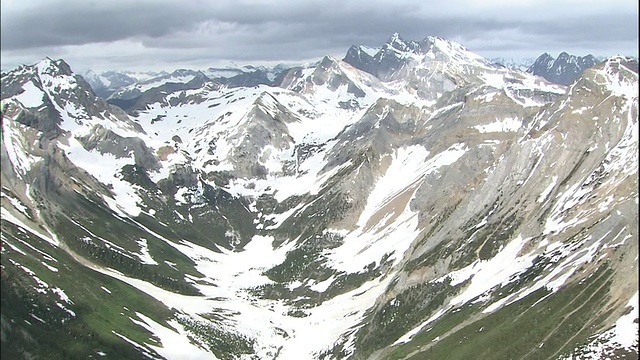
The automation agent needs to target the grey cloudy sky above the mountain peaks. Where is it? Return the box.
[0,0,638,71]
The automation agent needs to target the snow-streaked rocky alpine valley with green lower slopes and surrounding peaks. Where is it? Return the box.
[1,34,638,359]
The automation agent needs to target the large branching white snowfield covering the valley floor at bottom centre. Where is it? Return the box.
[86,232,400,360]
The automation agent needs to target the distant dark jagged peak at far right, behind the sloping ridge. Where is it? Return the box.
[527,52,600,85]
